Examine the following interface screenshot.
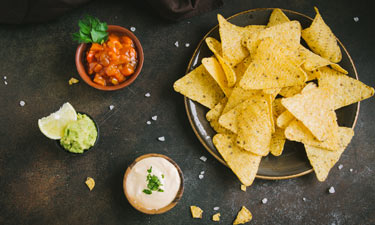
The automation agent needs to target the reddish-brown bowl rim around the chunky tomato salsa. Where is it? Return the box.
[75,25,144,91]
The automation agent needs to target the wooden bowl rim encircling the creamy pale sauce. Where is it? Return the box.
[123,153,184,215]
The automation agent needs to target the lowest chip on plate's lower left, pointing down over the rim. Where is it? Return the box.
[213,134,262,186]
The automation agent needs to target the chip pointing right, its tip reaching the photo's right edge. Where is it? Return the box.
[318,67,374,109]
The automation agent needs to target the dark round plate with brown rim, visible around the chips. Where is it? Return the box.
[185,8,359,180]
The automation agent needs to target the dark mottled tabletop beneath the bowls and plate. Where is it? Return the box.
[0,0,375,225]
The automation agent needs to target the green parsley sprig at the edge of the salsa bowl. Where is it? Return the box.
[73,15,108,44]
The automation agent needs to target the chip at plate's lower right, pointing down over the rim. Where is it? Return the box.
[305,127,354,182]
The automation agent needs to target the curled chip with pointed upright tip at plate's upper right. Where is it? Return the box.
[302,7,342,63]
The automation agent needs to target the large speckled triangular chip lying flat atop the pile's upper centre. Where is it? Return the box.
[240,39,307,89]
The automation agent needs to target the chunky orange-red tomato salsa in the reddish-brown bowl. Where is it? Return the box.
[86,33,138,86]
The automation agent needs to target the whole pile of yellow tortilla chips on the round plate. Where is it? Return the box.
[174,8,374,186]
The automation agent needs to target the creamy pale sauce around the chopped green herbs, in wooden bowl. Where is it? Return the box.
[125,157,181,210]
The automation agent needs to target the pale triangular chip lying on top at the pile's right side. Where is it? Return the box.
[281,85,338,141]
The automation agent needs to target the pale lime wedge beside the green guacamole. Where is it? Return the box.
[38,102,77,140]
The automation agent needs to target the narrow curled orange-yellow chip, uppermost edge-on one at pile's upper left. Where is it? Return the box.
[206,37,236,87]
